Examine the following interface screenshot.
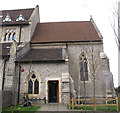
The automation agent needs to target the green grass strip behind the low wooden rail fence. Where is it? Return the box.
[68,105,117,112]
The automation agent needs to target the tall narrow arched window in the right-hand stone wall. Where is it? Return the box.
[80,53,88,81]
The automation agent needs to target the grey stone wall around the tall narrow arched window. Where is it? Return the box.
[68,43,105,97]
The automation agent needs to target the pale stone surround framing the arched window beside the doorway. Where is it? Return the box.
[25,71,41,98]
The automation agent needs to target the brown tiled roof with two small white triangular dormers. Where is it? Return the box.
[2,8,34,25]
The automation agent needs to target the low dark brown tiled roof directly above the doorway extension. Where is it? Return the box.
[16,48,64,62]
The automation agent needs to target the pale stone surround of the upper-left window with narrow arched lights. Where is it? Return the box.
[1,27,18,43]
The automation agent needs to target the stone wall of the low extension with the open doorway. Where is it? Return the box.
[20,62,69,103]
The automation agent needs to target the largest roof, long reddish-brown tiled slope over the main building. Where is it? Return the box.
[31,21,101,43]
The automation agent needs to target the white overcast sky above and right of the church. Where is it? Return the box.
[0,0,119,87]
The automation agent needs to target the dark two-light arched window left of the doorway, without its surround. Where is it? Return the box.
[28,74,39,94]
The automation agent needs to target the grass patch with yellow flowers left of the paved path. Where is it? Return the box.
[2,105,40,113]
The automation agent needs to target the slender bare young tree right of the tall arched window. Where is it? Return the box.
[89,45,102,110]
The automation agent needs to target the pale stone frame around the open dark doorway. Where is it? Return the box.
[46,77,62,103]
